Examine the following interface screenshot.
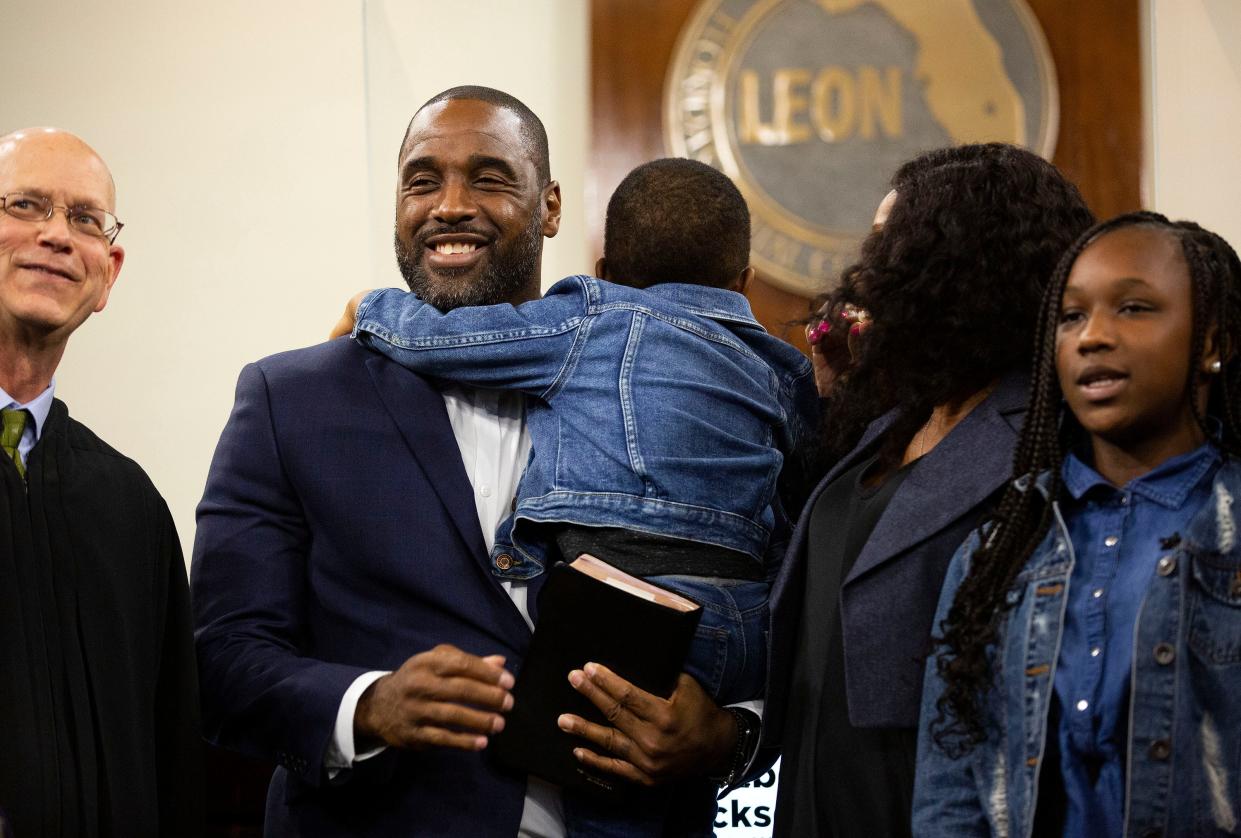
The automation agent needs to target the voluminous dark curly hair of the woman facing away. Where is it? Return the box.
[815,143,1095,472]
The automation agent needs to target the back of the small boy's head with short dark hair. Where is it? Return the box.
[603,158,750,288]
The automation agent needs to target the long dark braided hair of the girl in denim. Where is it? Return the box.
[932,212,1241,756]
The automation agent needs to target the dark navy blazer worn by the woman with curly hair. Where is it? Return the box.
[763,374,1028,762]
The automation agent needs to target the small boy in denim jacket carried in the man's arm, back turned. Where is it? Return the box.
[344,159,817,725]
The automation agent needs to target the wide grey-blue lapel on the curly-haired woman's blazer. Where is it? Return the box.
[845,375,1026,585]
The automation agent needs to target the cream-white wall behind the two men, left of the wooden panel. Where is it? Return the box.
[0,0,594,556]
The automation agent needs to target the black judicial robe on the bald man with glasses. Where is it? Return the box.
[0,400,204,838]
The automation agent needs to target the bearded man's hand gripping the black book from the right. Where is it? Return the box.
[558,663,737,786]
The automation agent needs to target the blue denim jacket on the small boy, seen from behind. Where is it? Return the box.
[354,276,818,579]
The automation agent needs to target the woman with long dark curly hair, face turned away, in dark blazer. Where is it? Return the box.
[763,144,1093,836]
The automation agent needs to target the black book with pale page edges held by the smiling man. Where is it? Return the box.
[488,555,702,798]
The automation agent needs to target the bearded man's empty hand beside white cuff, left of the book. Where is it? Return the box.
[354,644,513,751]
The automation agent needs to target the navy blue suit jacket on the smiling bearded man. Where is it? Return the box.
[191,339,530,836]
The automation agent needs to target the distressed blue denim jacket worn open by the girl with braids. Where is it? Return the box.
[913,459,1241,837]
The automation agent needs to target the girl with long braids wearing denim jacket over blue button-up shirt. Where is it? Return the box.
[913,212,1241,838]
